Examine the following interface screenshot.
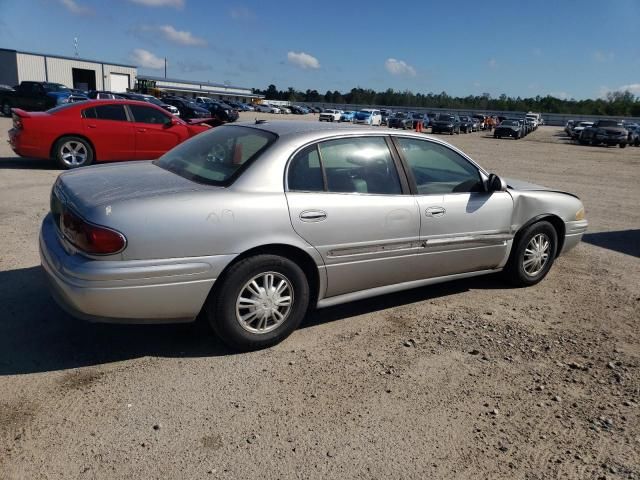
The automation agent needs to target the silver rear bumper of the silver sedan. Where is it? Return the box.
[39,214,234,323]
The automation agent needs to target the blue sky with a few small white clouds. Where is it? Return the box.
[0,0,640,99]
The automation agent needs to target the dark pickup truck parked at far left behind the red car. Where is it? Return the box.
[0,82,72,117]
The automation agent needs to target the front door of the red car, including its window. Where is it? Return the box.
[128,105,188,160]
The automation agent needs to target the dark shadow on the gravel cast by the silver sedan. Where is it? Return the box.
[0,266,508,376]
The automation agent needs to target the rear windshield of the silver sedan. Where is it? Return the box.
[155,126,277,186]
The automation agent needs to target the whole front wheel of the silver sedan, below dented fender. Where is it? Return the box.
[504,221,558,287]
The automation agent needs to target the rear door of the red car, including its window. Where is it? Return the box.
[82,104,136,161]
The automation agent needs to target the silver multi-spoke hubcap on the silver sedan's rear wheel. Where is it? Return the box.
[236,272,293,334]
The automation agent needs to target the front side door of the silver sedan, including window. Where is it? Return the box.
[394,136,513,277]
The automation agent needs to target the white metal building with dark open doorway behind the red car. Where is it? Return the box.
[0,48,138,92]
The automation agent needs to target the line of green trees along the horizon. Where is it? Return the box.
[253,84,640,117]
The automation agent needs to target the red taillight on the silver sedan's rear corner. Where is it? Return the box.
[60,210,127,255]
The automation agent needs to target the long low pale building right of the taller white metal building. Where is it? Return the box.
[138,75,264,102]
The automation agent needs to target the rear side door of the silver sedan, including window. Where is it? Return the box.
[287,136,420,297]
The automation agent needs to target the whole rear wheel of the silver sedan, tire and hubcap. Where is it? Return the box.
[205,254,309,351]
